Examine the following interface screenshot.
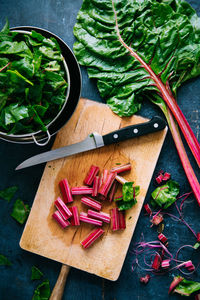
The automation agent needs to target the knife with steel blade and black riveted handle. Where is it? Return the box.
[16,116,166,170]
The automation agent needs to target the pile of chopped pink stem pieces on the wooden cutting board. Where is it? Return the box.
[52,163,131,249]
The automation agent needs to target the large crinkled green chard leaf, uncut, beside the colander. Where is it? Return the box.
[73,0,200,116]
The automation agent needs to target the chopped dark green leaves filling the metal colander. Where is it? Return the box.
[0,22,69,135]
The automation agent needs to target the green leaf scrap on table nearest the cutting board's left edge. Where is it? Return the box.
[11,199,30,224]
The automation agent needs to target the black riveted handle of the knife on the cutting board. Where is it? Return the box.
[103,116,166,145]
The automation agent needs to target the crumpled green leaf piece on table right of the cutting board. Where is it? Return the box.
[151,180,180,208]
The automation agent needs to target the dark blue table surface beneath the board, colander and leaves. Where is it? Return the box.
[0,0,200,300]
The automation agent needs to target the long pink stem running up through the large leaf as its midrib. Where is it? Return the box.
[112,0,200,167]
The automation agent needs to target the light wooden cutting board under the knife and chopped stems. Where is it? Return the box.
[20,99,167,280]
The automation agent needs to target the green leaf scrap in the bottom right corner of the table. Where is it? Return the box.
[174,279,200,296]
